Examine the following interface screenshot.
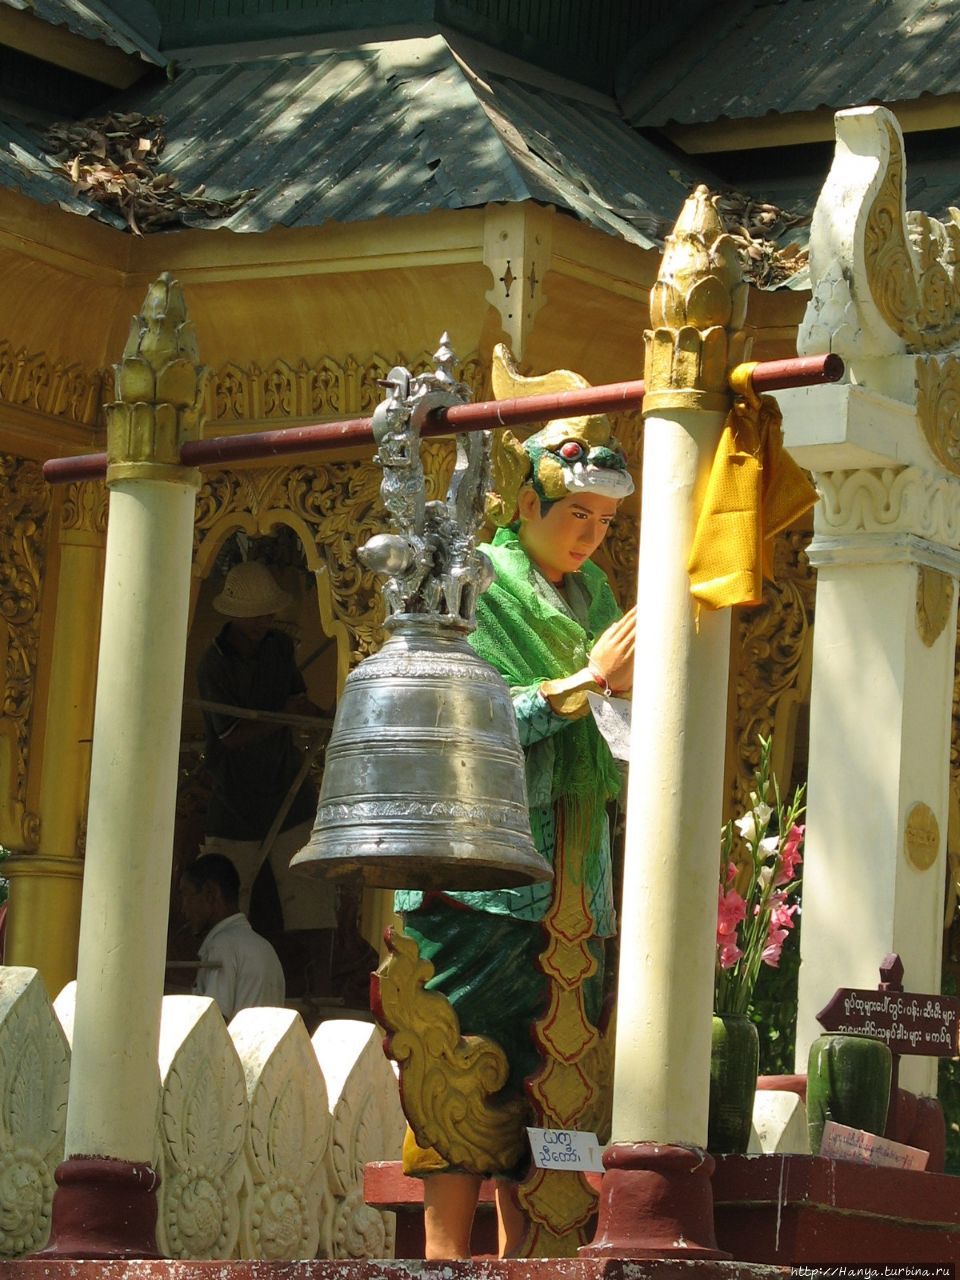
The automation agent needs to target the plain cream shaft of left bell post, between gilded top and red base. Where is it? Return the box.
[65,473,200,1164]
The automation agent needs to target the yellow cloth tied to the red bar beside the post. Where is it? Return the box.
[687,365,817,609]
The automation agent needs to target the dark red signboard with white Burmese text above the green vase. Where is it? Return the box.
[817,987,960,1057]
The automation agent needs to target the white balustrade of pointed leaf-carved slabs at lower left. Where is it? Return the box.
[0,966,404,1261]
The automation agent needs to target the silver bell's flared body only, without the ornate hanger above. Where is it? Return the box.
[291,621,552,890]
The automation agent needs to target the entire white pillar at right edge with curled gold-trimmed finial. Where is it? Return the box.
[780,108,960,1093]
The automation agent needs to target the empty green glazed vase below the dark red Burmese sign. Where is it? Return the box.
[806,1034,893,1156]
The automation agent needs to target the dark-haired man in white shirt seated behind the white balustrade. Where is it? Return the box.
[180,854,285,1021]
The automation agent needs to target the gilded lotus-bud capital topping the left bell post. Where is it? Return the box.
[106,271,209,485]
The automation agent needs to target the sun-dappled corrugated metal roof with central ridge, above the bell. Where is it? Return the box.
[37,36,696,247]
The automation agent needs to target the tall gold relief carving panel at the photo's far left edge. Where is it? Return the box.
[0,453,50,849]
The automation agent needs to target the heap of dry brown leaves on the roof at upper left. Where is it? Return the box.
[44,111,255,236]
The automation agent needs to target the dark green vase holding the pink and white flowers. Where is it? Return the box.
[707,1014,760,1156]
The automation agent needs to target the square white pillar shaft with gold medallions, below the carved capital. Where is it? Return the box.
[796,532,960,1094]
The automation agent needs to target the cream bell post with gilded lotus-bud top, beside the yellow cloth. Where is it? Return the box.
[598,187,746,1152]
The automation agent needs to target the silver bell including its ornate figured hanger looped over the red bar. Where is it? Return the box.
[291,345,553,890]
